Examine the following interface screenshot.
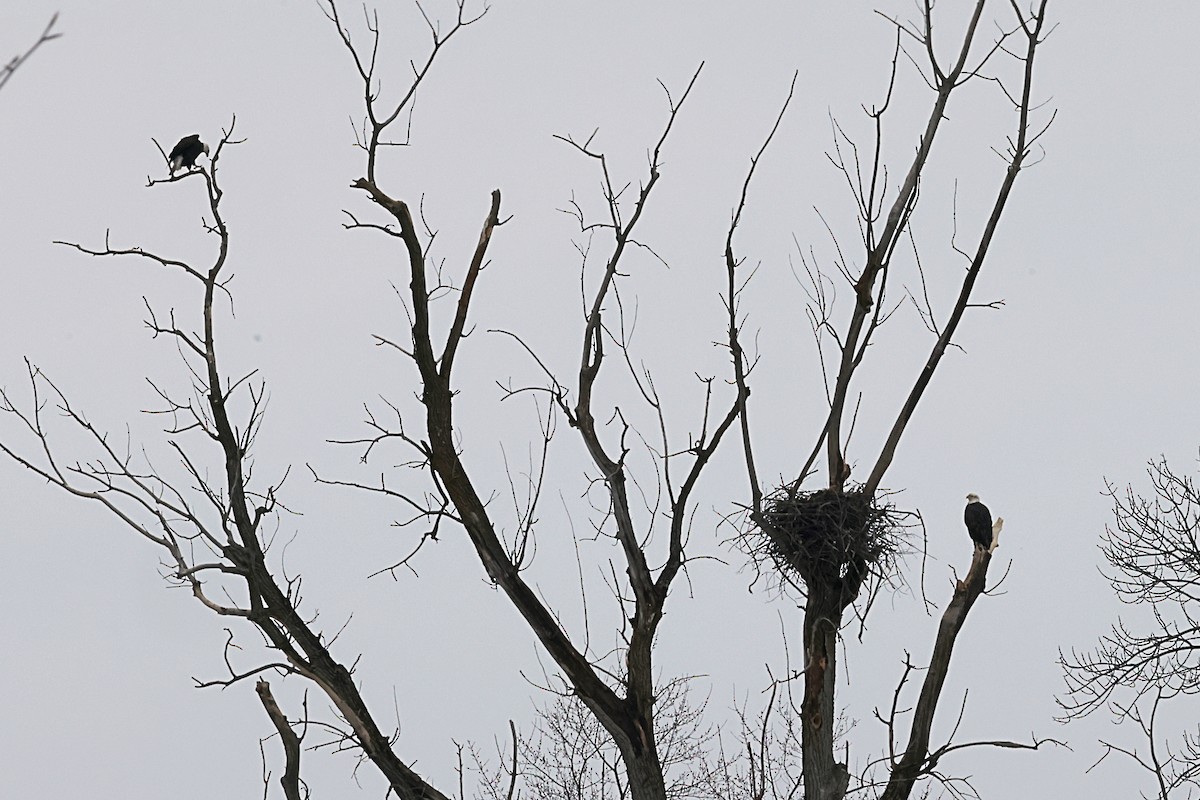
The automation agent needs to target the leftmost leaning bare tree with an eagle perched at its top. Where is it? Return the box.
[0,124,446,800]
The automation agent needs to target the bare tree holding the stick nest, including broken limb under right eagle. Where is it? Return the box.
[725,0,1052,800]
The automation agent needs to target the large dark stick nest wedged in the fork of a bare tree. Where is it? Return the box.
[748,488,908,610]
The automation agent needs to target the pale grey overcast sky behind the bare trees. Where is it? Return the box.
[0,0,1200,799]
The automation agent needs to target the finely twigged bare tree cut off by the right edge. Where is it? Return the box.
[1058,458,1200,800]
